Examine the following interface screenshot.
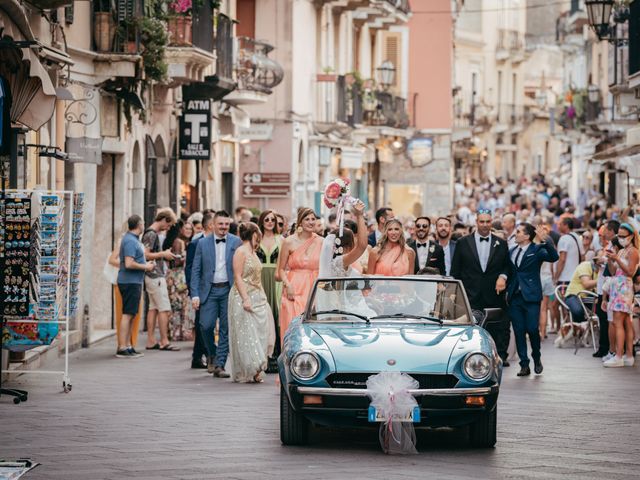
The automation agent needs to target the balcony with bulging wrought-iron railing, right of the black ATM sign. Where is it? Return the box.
[225,37,284,105]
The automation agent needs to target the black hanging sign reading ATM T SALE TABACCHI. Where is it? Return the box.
[180,99,211,160]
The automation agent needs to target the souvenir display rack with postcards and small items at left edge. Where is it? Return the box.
[0,190,74,403]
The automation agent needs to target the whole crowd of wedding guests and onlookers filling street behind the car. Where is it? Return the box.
[109,177,640,383]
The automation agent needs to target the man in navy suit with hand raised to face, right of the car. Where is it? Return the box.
[507,223,558,377]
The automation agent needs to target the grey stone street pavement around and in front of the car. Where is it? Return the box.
[0,336,640,480]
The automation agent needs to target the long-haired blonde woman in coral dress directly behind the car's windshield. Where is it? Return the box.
[367,218,416,276]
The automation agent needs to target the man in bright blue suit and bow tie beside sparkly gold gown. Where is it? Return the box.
[189,211,242,378]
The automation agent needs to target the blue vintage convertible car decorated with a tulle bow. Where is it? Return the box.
[278,276,502,447]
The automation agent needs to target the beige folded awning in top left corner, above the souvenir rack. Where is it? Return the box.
[0,6,56,130]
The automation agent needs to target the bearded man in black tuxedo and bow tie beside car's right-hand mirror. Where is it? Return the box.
[451,209,511,364]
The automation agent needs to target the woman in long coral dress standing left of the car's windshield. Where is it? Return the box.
[276,208,322,341]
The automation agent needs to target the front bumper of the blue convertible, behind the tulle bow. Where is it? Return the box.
[288,384,500,427]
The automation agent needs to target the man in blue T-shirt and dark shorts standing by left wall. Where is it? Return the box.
[116,215,155,358]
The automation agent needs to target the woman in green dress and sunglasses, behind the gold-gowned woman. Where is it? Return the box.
[256,210,282,373]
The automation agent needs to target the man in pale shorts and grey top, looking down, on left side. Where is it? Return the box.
[142,208,180,351]
